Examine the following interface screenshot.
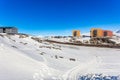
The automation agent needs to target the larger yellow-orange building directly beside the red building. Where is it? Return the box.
[90,28,103,38]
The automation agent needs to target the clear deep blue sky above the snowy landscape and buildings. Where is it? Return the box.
[0,0,120,35]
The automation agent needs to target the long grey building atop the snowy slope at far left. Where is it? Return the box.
[0,27,18,34]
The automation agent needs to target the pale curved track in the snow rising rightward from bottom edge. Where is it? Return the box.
[62,56,101,80]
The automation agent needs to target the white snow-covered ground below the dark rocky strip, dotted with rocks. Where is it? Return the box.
[0,34,120,80]
